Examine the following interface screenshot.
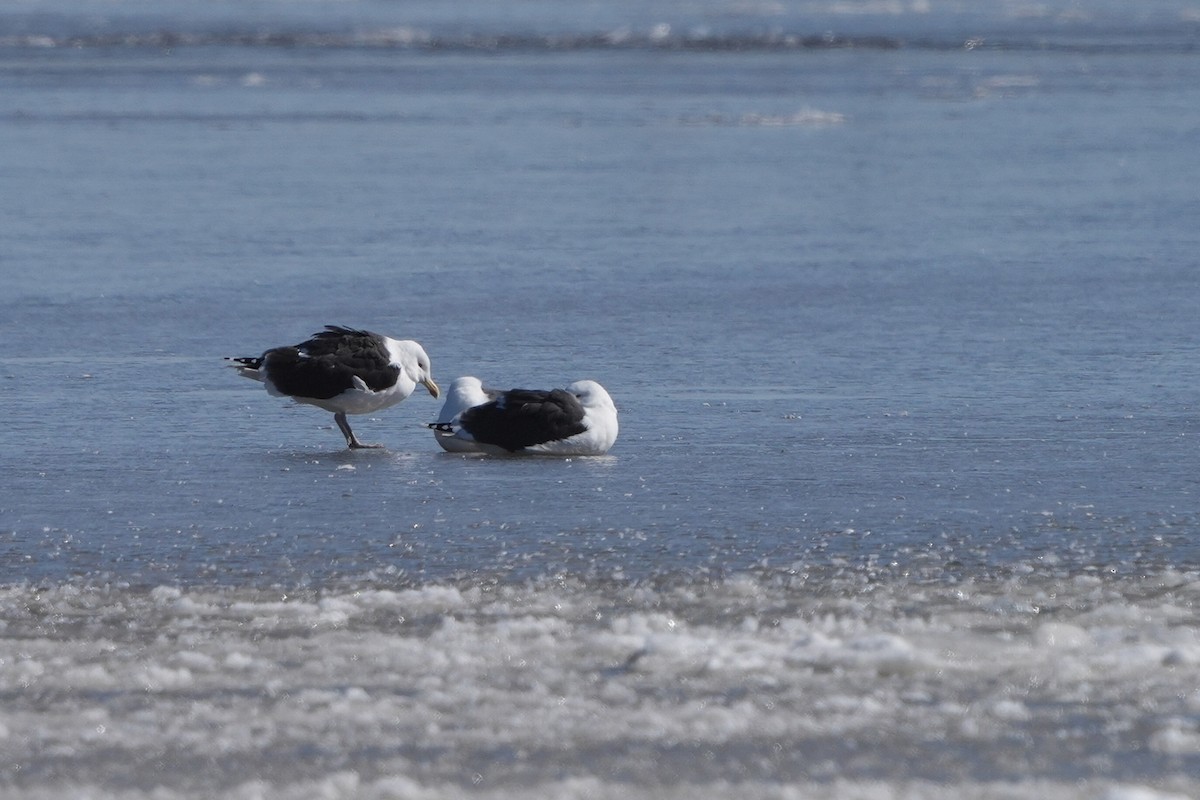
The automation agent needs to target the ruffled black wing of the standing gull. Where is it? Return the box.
[263,325,400,399]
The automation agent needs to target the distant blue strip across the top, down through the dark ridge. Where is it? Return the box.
[0,0,1198,52]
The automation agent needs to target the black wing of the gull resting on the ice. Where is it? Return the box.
[460,389,587,452]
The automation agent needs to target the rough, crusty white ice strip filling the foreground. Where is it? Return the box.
[0,571,1200,800]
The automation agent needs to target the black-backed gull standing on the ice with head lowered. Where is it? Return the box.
[228,325,440,449]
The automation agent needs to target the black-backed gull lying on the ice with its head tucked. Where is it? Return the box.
[428,377,617,456]
